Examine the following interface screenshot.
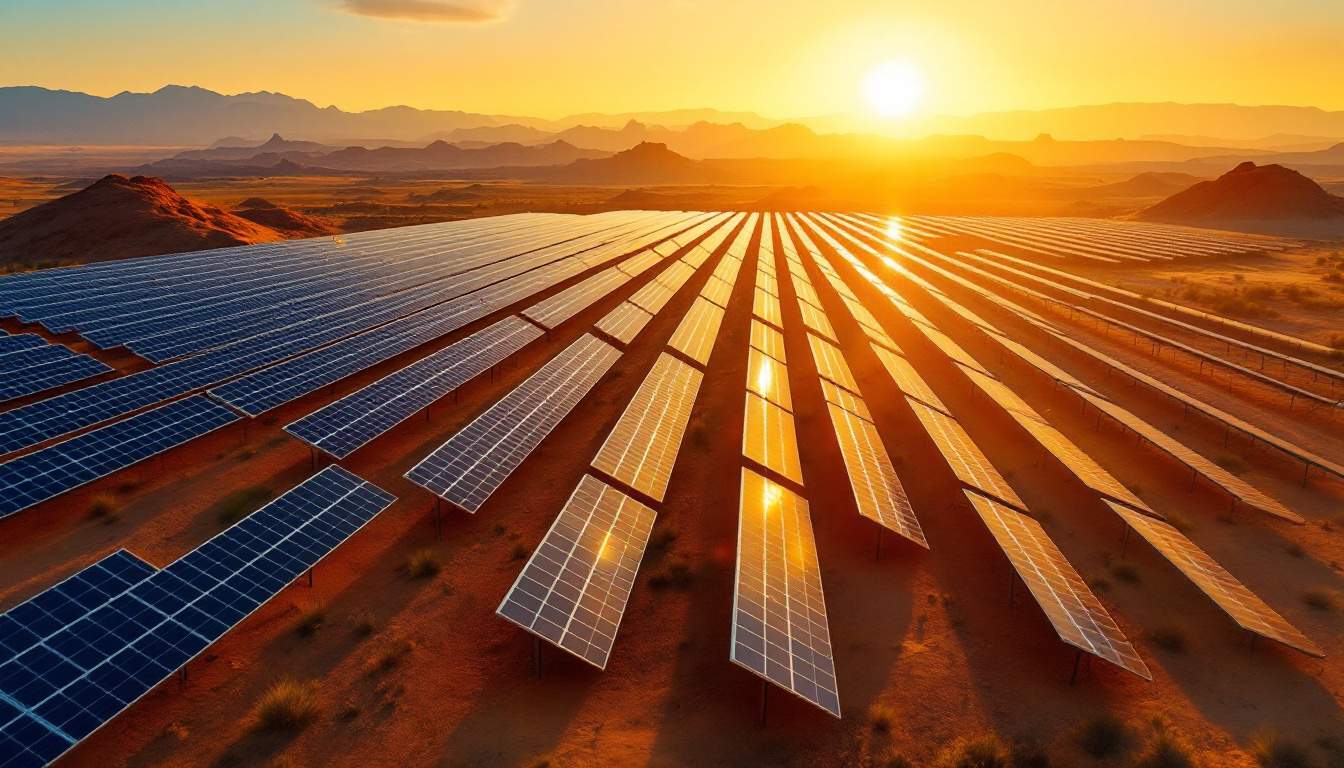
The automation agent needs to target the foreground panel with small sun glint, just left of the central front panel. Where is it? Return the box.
[496,475,655,670]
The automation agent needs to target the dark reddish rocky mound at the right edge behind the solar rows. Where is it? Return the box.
[1138,161,1344,223]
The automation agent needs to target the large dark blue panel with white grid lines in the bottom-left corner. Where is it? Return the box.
[0,467,395,768]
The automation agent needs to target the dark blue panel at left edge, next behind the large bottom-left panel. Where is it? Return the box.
[0,394,238,518]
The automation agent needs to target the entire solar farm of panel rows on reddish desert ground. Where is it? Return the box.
[0,211,1344,768]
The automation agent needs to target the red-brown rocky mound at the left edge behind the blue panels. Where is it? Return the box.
[0,174,285,265]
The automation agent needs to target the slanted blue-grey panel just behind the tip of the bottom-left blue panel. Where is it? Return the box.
[285,316,542,459]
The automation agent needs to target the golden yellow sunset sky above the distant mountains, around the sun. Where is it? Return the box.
[0,0,1344,120]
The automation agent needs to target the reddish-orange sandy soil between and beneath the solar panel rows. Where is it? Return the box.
[0,216,1344,767]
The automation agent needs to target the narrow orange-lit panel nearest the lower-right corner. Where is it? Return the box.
[1103,499,1325,658]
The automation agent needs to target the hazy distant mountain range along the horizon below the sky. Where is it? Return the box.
[0,85,1344,149]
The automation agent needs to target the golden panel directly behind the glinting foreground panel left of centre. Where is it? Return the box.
[593,352,704,502]
